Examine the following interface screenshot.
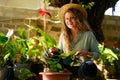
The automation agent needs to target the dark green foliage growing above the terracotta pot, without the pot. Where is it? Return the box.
[46,51,78,72]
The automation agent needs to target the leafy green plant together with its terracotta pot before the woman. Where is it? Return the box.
[40,53,71,80]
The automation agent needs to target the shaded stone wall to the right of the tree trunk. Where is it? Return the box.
[102,16,120,42]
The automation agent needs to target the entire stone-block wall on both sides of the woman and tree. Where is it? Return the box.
[0,16,120,42]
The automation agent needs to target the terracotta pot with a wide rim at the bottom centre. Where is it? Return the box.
[39,72,71,80]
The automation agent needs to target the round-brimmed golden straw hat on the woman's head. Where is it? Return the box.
[59,3,87,21]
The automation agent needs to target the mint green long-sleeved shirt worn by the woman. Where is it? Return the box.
[58,31,100,59]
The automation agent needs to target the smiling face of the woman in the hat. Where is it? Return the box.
[65,11,78,29]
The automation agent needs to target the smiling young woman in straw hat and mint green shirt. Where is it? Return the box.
[51,3,100,80]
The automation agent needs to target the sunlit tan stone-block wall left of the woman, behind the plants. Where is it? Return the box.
[0,19,61,41]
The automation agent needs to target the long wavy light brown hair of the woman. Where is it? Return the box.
[63,8,90,52]
